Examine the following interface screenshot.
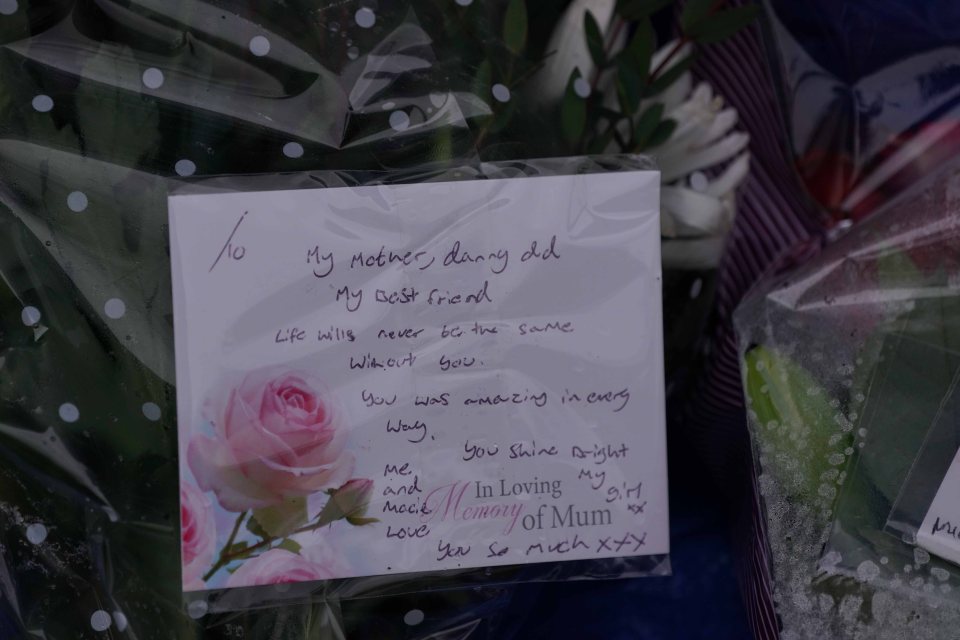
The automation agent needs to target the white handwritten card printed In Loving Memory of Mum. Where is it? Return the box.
[170,171,669,591]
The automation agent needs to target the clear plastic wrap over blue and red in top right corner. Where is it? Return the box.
[764,0,960,220]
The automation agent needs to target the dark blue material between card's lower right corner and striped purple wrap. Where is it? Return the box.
[494,432,752,640]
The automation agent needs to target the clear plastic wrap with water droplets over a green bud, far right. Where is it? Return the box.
[736,156,960,639]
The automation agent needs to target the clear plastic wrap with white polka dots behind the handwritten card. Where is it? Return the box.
[0,0,666,640]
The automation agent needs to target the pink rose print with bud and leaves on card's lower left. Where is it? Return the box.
[181,367,377,591]
